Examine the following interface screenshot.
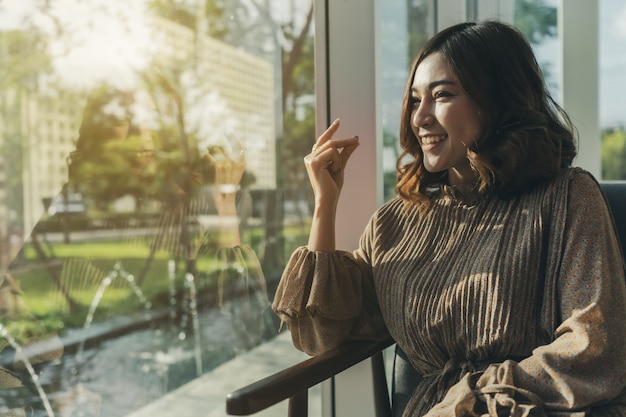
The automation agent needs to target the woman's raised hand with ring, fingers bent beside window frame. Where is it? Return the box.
[304,119,359,205]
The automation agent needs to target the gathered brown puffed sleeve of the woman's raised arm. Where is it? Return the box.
[272,218,386,355]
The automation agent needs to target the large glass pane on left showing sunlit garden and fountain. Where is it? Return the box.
[0,0,314,417]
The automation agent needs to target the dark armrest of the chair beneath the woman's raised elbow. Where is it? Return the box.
[226,337,395,416]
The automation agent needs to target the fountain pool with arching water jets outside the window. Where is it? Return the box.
[0,247,270,417]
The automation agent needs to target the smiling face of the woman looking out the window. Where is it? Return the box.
[411,53,483,185]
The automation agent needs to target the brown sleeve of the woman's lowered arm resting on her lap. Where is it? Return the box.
[428,170,626,417]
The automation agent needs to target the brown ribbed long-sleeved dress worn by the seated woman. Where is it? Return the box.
[273,168,626,416]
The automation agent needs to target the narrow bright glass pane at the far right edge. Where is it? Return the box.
[599,0,626,180]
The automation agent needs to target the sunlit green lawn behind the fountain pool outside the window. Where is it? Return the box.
[0,221,308,344]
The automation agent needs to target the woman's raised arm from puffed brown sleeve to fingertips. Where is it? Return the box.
[272,121,387,355]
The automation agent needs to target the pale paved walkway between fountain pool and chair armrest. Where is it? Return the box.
[128,331,321,417]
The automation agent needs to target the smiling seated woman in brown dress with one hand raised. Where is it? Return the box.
[273,22,626,416]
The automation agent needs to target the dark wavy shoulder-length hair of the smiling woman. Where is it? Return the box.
[396,21,576,204]
